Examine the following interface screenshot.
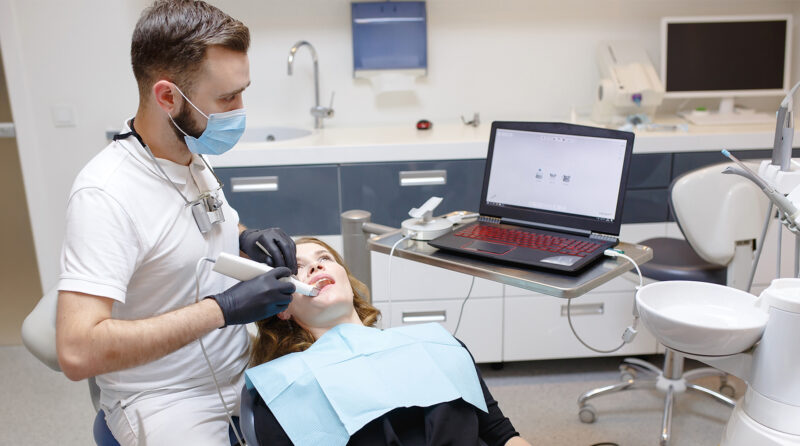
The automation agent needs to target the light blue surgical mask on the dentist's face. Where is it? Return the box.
[167,85,246,155]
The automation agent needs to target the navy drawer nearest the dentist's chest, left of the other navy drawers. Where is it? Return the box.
[215,165,342,235]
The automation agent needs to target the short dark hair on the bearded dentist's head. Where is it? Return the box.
[131,0,250,100]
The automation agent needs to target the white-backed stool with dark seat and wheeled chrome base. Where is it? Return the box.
[578,163,768,445]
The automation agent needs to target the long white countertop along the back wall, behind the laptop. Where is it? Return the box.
[209,118,775,167]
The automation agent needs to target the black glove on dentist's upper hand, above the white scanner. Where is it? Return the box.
[239,228,297,274]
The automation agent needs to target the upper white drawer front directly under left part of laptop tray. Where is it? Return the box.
[371,252,503,303]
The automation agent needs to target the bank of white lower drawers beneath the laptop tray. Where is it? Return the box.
[371,223,667,362]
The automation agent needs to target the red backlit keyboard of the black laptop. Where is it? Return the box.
[455,225,601,257]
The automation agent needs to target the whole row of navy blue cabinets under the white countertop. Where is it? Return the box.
[216,150,776,235]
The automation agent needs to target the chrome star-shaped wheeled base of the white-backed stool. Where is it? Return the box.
[578,349,736,446]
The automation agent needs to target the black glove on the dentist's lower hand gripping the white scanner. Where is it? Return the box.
[209,266,295,326]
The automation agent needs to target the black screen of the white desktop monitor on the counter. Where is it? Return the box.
[664,20,786,92]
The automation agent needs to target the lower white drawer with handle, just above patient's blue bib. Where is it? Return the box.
[374,297,503,362]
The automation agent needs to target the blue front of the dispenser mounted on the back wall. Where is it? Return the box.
[351,2,428,71]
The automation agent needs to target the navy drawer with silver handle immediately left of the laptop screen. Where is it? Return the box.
[341,160,486,228]
